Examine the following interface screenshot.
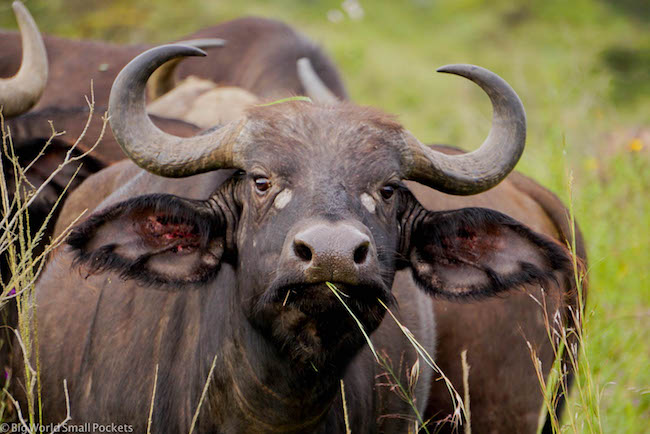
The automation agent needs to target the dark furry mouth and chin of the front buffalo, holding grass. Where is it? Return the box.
[252,280,395,369]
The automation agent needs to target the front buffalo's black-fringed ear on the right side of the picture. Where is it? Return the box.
[407,208,570,298]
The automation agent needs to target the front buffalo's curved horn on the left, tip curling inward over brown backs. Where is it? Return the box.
[108,44,245,178]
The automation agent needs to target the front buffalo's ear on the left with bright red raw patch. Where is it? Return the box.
[67,194,225,289]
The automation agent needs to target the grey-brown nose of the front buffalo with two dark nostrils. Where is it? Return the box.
[287,223,376,285]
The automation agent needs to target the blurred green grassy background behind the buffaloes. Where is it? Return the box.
[0,0,650,433]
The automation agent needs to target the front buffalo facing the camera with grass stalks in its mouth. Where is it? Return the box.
[8,45,584,433]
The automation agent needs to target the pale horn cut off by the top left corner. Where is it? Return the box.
[0,1,47,117]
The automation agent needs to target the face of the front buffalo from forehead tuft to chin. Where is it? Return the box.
[237,103,400,367]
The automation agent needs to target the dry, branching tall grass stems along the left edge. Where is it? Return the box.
[0,95,108,433]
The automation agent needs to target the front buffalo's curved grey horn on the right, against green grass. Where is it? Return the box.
[404,64,526,195]
